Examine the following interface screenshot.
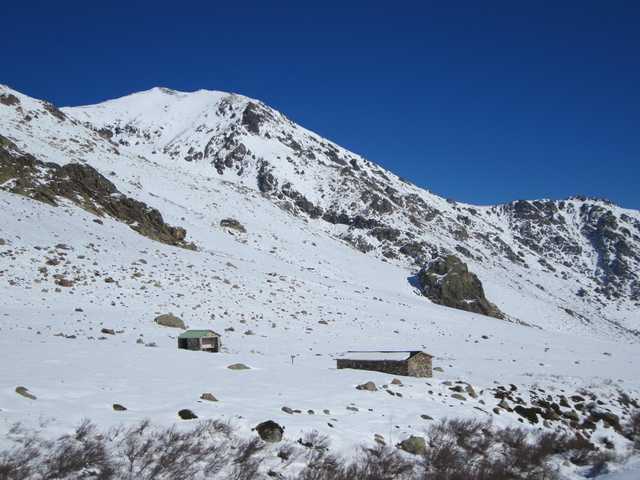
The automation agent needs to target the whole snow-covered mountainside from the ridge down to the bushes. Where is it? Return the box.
[0,87,640,476]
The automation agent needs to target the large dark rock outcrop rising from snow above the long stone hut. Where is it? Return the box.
[418,255,504,319]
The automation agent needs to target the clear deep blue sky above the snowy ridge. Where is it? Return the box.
[5,0,640,208]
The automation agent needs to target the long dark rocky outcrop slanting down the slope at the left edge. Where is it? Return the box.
[0,137,195,249]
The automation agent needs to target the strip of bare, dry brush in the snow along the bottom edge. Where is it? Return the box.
[0,413,640,480]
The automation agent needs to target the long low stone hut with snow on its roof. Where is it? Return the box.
[336,350,433,377]
